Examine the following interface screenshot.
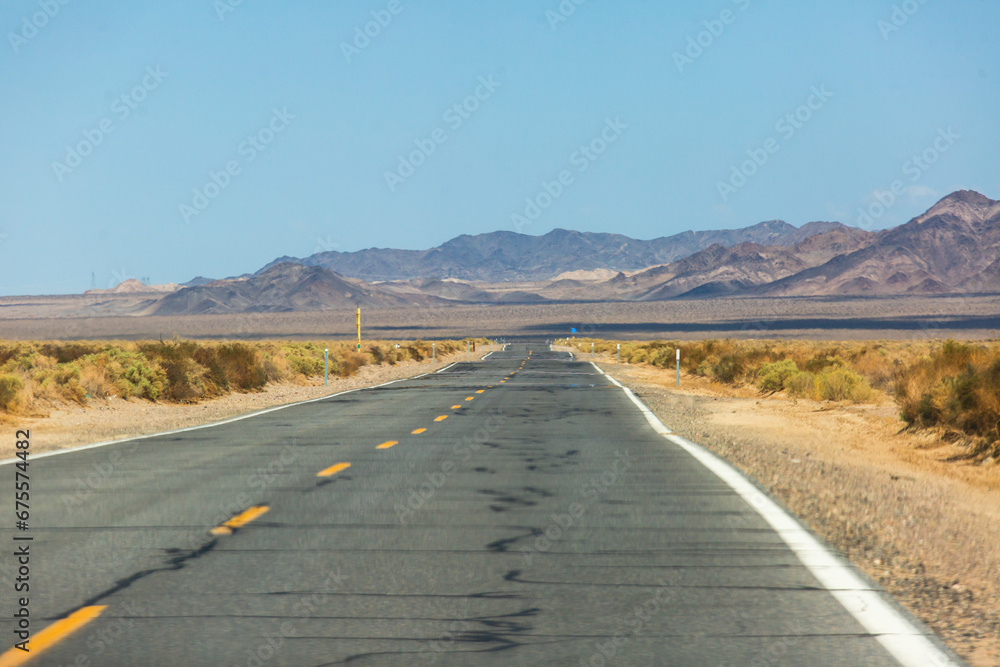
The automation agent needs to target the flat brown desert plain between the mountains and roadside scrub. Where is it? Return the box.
[0,295,1000,340]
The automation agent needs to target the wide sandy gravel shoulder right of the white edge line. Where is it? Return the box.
[577,351,1000,667]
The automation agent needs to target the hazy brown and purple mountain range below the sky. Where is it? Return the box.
[143,190,1000,315]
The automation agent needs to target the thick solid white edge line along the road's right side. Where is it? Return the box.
[591,362,959,667]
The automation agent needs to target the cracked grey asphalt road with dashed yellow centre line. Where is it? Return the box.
[0,344,960,667]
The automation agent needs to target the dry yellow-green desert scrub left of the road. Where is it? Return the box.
[0,339,482,415]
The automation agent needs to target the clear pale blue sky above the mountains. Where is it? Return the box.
[0,0,1000,294]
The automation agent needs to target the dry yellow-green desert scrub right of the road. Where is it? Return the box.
[560,338,1000,458]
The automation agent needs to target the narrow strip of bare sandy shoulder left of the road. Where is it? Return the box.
[0,352,472,459]
